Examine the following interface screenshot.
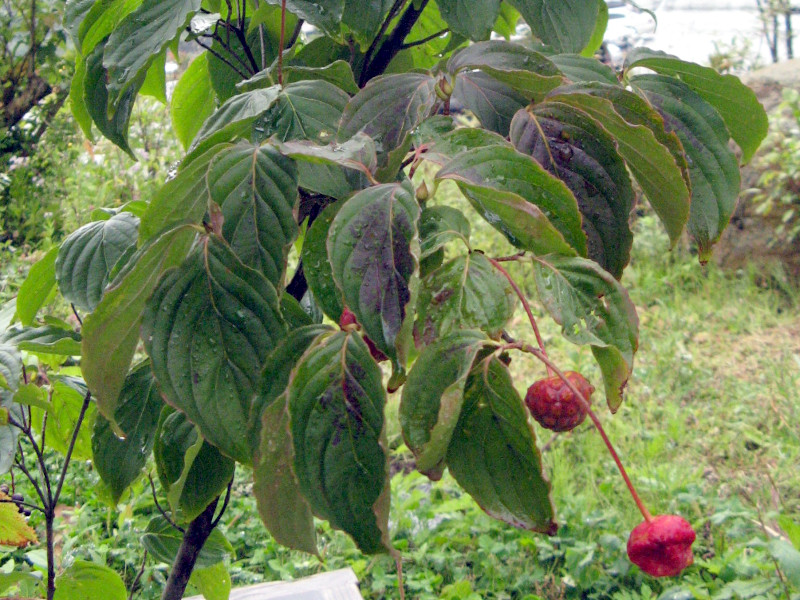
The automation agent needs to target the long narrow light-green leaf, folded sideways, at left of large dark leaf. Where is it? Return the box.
[81,226,196,426]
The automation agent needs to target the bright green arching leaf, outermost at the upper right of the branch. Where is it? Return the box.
[625,48,769,163]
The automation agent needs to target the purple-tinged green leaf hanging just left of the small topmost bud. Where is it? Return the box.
[339,73,437,180]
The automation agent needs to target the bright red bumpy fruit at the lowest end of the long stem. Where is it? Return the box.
[628,515,696,577]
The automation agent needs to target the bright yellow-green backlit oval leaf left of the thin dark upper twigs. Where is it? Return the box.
[170,53,214,148]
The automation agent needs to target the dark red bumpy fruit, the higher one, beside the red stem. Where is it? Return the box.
[525,371,594,431]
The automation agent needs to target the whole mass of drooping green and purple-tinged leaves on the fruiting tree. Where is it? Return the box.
[2,0,766,598]
